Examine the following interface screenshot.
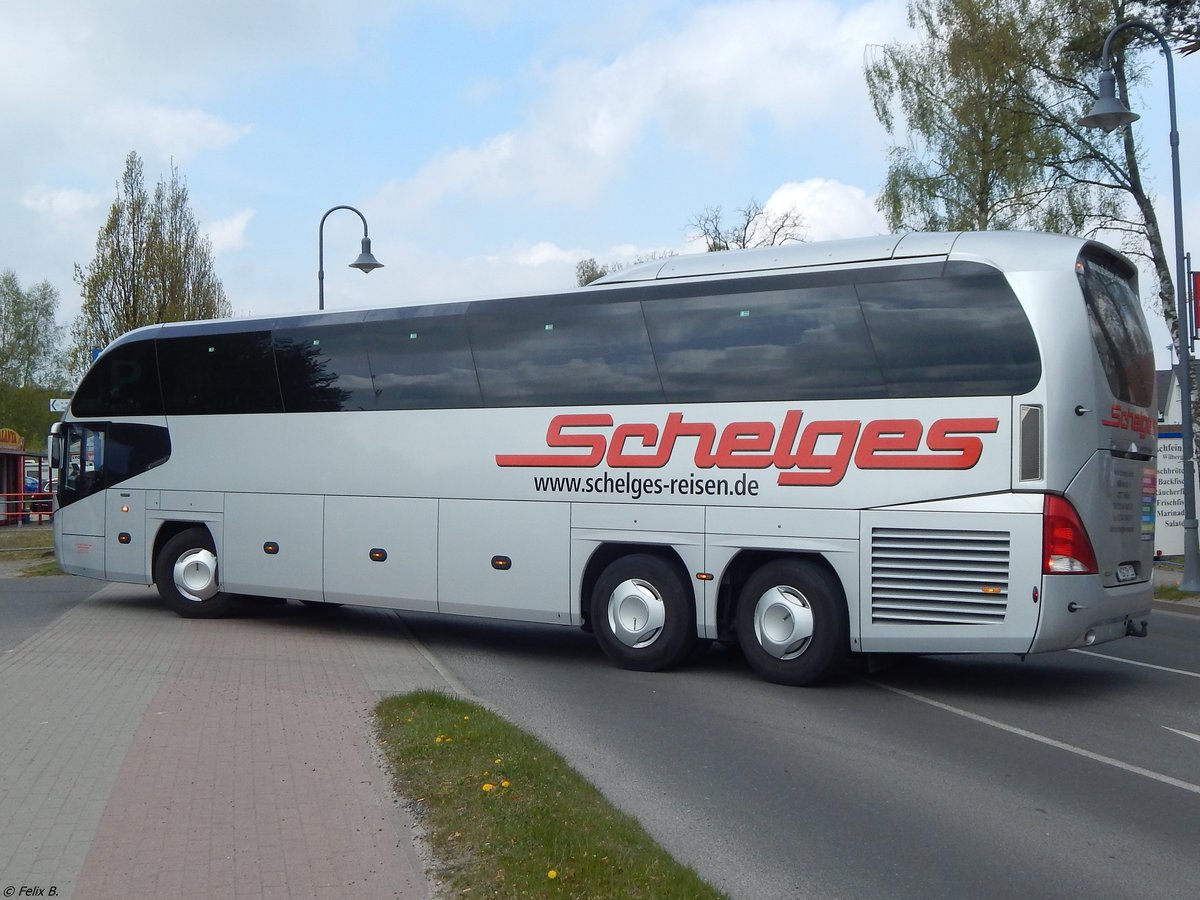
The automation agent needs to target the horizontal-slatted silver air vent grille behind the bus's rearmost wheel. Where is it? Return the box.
[871,528,1009,625]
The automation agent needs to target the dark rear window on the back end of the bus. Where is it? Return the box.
[1076,251,1154,407]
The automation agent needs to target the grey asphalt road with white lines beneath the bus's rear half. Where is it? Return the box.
[404,613,1200,900]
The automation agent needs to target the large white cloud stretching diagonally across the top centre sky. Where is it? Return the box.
[380,0,902,220]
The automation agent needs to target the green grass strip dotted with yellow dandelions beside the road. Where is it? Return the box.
[376,691,724,900]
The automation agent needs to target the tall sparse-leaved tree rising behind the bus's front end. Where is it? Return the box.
[68,152,232,374]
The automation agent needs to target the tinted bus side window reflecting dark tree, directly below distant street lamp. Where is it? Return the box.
[274,324,376,413]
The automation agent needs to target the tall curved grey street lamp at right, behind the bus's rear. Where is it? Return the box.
[1079,20,1200,593]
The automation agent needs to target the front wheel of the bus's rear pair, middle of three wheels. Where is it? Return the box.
[590,553,696,672]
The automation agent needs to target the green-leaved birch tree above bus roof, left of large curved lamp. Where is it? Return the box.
[866,0,1116,233]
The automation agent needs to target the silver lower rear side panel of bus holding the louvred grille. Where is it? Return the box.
[862,508,1042,653]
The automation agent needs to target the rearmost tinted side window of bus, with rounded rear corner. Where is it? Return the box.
[858,271,1042,397]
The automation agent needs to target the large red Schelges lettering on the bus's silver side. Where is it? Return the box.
[496,409,1000,486]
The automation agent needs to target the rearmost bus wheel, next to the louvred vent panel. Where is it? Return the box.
[737,559,850,685]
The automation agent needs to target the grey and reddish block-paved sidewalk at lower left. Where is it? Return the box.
[0,582,446,900]
